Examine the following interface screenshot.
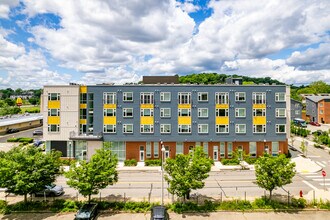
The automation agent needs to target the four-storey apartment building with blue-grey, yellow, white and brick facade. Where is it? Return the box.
[42,83,290,162]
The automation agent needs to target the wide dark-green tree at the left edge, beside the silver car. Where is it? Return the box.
[0,146,61,202]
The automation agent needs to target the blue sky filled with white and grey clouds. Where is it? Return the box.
[0,0,330,89]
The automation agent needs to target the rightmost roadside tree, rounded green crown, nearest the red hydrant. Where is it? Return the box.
[255,154,296,199]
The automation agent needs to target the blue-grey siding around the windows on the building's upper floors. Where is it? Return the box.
[88,85,286,142]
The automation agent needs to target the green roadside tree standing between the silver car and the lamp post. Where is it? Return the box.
[65,146,118,202]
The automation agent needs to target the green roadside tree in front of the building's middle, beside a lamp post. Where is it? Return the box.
[164,147,212,200]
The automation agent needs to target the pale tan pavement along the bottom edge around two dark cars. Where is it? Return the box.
[0,211,330,220]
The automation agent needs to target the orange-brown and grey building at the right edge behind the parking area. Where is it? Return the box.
[306,94,330,124]
